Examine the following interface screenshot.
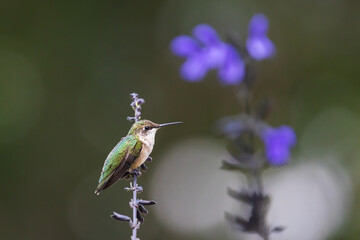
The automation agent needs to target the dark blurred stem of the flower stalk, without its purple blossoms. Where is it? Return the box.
[220,74,272,240]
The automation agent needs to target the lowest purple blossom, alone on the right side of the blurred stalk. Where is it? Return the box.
[261,126,296,166]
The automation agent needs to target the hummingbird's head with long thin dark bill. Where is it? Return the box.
[128,120,182,138]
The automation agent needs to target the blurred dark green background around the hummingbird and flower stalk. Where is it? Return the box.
[0,0,360,240]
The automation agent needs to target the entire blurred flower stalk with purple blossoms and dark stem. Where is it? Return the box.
[170,14,296,240]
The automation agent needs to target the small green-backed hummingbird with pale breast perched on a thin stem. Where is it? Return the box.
[95,120,182,195]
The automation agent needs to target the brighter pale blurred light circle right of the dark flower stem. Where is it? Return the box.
[231,158,352,240]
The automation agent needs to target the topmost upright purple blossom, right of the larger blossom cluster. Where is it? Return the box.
[246,14,276,61]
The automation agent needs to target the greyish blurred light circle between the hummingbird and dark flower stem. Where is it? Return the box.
[151,139,242,235]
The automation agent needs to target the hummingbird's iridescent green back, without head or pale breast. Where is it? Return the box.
[99,135,141,185]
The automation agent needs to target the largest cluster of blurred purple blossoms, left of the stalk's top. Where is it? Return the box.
[170,24,245,85]
